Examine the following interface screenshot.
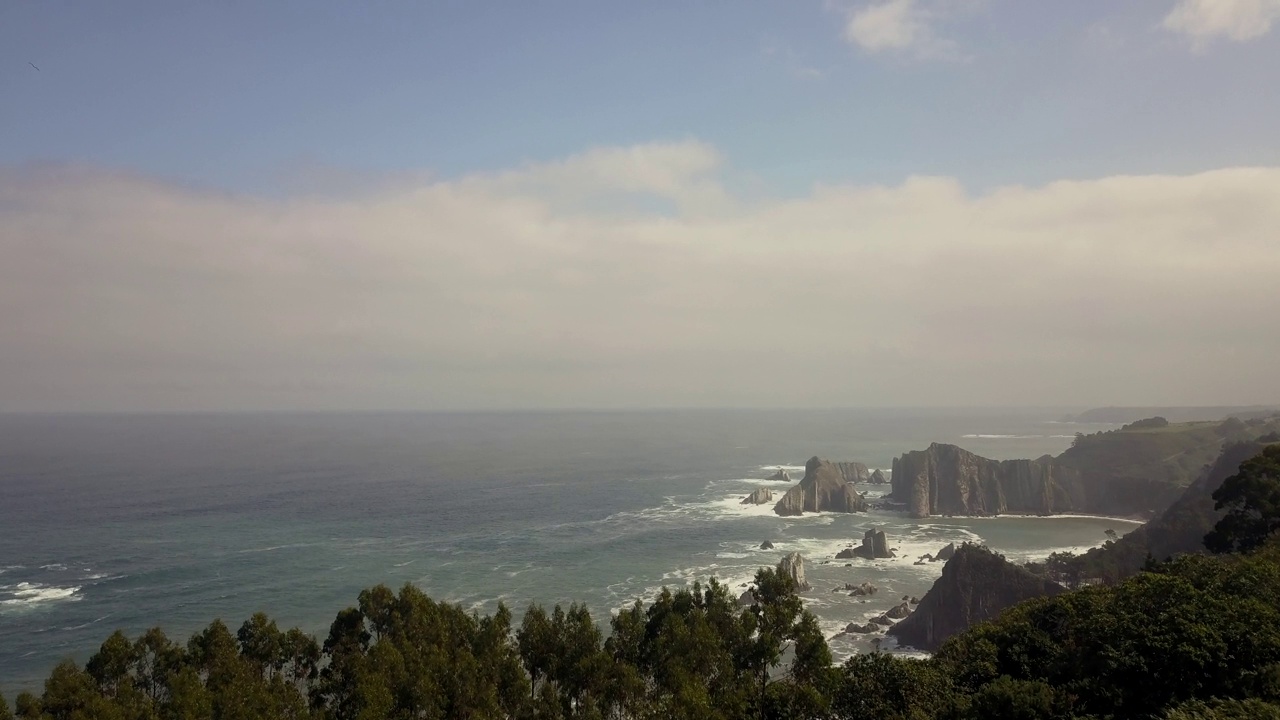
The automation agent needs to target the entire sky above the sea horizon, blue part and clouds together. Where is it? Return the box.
[0,0,1280,411]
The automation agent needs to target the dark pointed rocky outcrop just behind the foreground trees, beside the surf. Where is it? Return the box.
[887,543,1065,652]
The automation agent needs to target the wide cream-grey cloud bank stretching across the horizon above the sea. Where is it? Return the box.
[0,142,1280,410]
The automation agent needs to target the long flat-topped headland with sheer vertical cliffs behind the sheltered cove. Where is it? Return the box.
[890,443,1181,518]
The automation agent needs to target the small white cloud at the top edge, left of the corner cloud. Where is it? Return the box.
[845,0,955,58]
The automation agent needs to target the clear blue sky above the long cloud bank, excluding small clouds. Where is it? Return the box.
[0,0,1280,193]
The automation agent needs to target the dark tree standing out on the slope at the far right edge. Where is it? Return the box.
[1204,445,1280,553]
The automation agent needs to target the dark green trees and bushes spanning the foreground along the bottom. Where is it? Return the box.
[20,543,1280,720]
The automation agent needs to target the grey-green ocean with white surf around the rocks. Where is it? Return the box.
[0,409,1135,698]
